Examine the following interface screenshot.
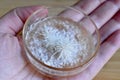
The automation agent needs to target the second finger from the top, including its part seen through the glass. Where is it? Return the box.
[80,0,120,33]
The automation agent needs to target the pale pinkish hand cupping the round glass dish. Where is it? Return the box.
[0,0,120,80]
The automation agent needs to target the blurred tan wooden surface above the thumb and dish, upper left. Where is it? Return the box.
[0,0,78,16]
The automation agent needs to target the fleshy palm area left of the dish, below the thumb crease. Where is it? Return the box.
[0,34,48,80]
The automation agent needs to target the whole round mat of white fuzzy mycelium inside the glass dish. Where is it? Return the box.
[25,17,91,68]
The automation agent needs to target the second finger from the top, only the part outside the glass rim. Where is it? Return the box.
[90,0,120,28]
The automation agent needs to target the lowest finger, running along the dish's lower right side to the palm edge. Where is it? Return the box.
[76,30,120,80]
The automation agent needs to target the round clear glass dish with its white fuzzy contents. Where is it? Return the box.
[22,7,100,77]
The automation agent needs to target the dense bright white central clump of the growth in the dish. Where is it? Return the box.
[42,26,79,62]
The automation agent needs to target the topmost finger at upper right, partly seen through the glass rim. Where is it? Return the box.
[60,0,105,22]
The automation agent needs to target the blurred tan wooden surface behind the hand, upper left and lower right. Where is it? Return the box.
[0,0,120,80]
